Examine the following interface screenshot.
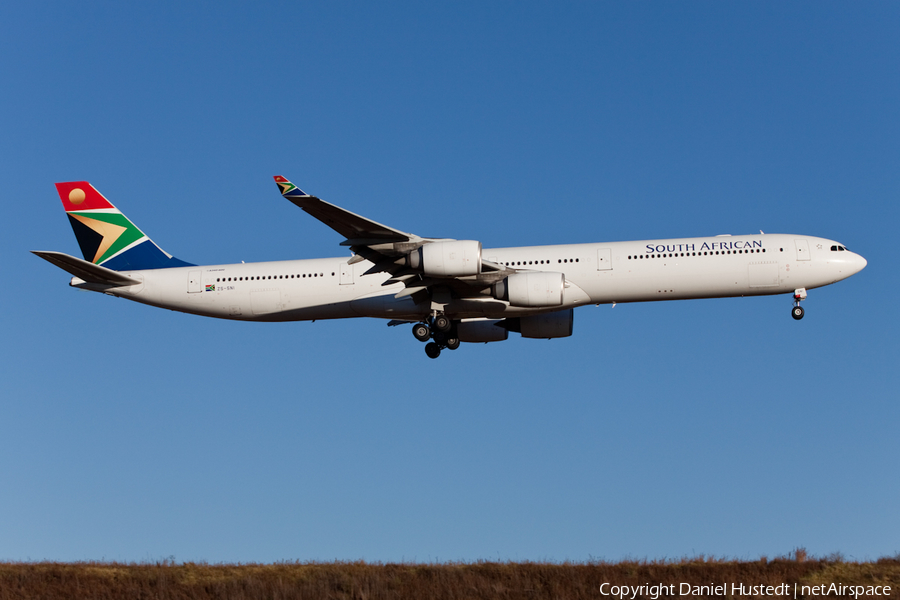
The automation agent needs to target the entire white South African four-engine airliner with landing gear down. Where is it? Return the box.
[34,176,866,358]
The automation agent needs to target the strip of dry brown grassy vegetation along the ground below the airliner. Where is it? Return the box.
[0,549,900,600]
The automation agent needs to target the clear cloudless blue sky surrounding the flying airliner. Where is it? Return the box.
[0,2,900,562]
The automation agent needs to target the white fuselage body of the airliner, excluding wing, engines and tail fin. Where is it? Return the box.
[81,234,866,321]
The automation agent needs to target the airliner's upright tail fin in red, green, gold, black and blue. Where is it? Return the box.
[56,181,192,271]
